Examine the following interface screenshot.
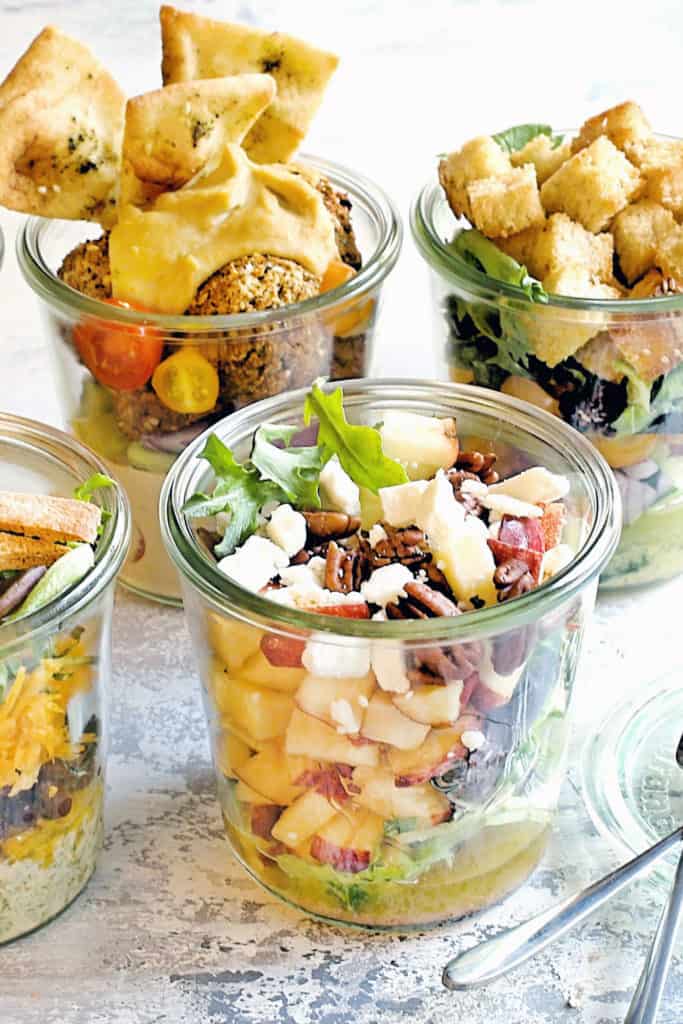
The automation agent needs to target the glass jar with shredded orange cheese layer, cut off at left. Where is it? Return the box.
[0,415,130,944]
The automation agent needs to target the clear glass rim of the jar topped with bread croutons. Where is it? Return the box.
[410,132,683,321]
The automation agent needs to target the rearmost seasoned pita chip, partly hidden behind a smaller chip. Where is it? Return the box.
[161,7,339,164]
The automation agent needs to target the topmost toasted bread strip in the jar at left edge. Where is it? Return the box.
[0,490,101,548]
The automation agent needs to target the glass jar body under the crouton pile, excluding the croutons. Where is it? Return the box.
[411,175,683,589]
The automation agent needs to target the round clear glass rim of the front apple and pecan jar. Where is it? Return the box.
[159,379,622,644]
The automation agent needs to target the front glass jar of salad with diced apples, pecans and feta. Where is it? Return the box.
[161,381,620,928]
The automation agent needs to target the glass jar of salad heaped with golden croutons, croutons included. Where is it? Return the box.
[412,102,683,588]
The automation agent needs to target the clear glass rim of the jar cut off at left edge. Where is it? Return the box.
[0,413,131,657]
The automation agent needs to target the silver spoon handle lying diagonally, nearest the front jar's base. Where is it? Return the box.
[442,827,683,990]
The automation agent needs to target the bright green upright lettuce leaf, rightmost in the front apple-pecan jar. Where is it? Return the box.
[303,384,408,494]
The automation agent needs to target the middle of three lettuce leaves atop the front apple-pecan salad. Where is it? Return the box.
[251,423,332,509]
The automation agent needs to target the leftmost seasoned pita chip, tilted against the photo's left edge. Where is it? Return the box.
[0,28,125,224]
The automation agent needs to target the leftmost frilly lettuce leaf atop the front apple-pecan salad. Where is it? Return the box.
[182,434,282,558]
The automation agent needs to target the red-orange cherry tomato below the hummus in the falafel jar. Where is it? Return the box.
[74,299,164,391]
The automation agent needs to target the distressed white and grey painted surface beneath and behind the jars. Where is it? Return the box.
[0,0,683,1024]
